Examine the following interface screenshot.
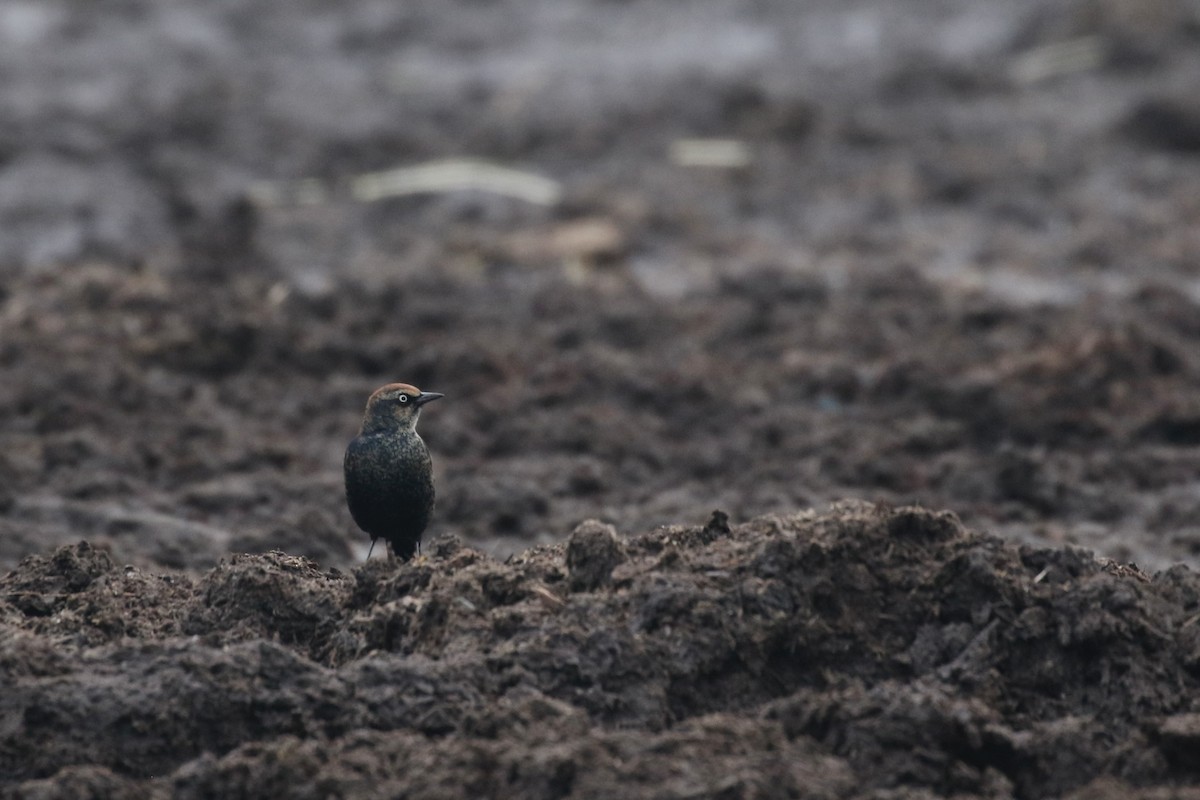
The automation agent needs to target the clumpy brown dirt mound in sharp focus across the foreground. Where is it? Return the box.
[0,504,1200,798]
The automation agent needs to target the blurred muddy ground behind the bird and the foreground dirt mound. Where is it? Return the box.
[0,0,1200,569]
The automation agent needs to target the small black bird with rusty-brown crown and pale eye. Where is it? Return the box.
[342,384,444,561]
